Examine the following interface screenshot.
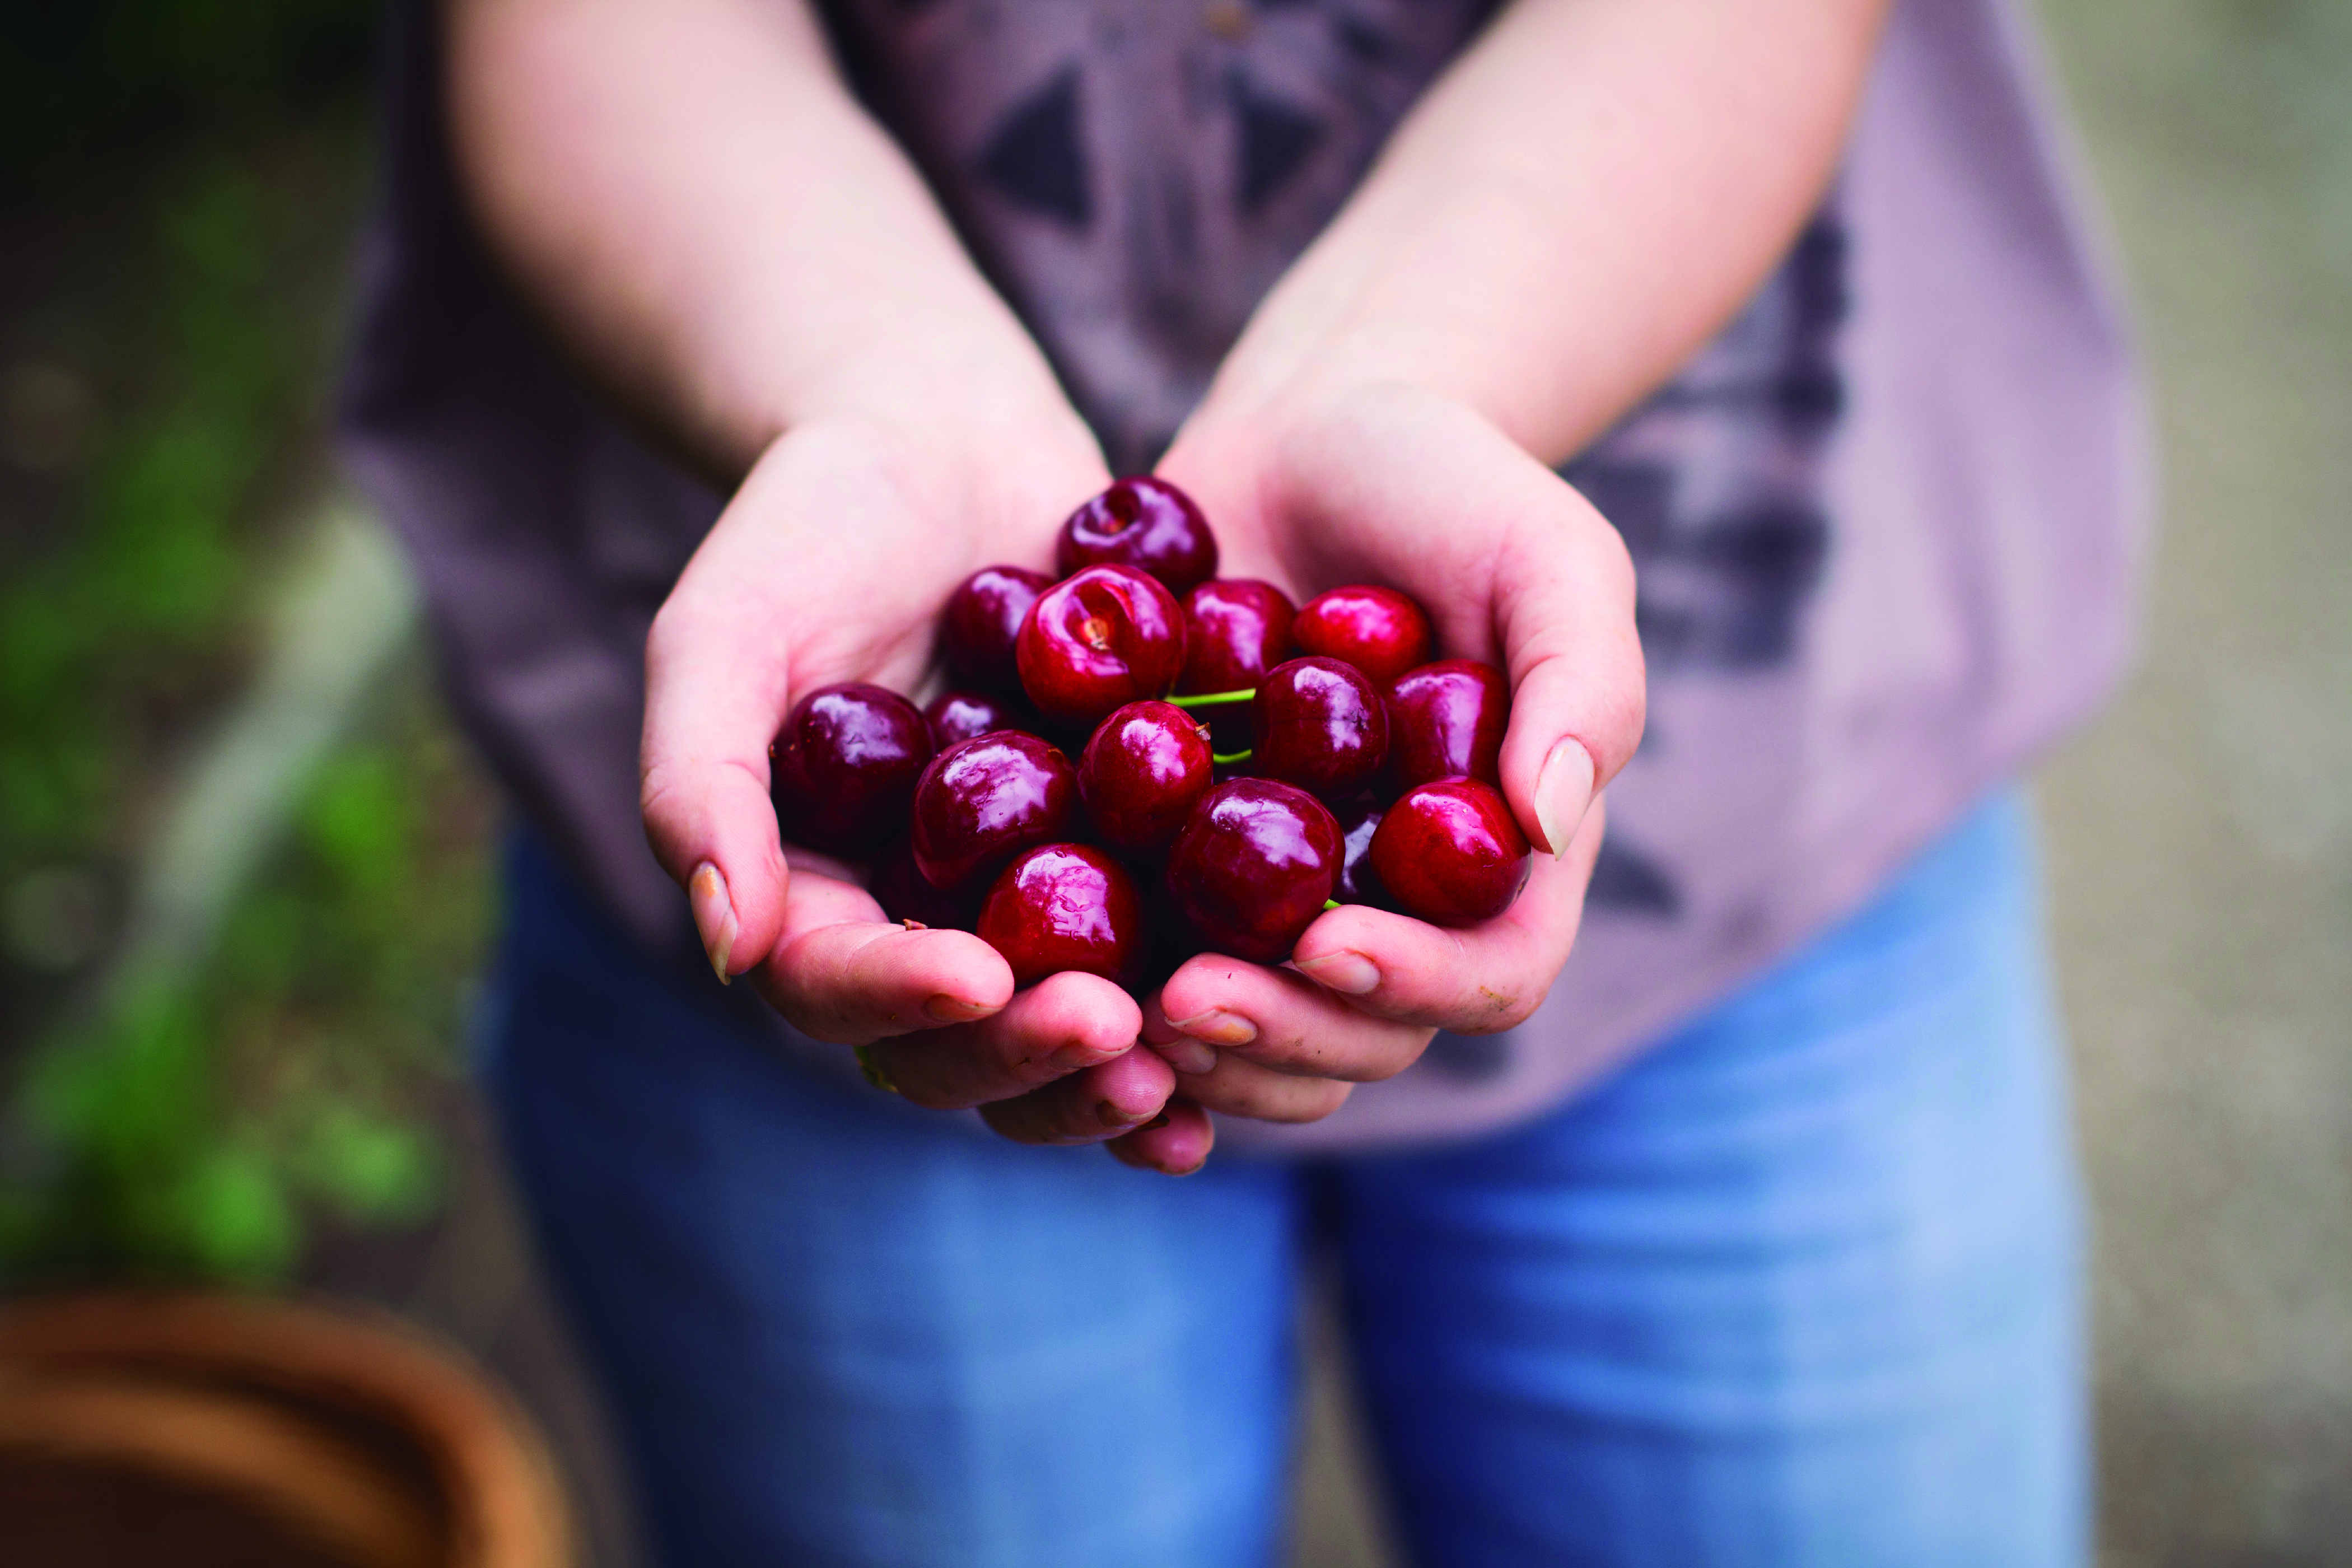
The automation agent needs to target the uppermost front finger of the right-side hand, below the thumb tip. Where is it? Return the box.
[1294,811,1607,1034]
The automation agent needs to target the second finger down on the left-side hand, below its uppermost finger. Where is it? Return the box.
[872,973,1143,1109]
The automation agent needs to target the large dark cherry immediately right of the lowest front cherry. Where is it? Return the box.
[1166,778,1341,964]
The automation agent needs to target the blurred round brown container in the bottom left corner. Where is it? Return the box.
[0,1293,574,1568]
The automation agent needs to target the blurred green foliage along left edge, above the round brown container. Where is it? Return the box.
[0,0,489,1281]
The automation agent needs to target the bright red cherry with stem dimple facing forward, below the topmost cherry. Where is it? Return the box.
[1016,567,1183,724]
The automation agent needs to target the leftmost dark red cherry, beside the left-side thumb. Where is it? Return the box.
[769,684,931,856]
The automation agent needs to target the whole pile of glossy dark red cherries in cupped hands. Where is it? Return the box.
[772,477,1529,987]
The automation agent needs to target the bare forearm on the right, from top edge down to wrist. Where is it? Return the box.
[1200,0,1886,461]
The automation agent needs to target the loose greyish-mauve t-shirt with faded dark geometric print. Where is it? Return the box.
[343,0,2148,1147]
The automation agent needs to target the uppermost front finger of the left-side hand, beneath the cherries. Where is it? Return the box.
[753,872,1014,1046]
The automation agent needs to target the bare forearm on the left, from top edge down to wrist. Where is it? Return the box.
[447,0,1086,482]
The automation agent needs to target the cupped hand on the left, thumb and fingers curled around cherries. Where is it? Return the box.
[640,414,1207,1168]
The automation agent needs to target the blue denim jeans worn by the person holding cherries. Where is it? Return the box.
[484,795,2086,1568]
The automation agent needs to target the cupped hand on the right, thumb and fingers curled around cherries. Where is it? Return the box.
[1115,388,1644,1164]
